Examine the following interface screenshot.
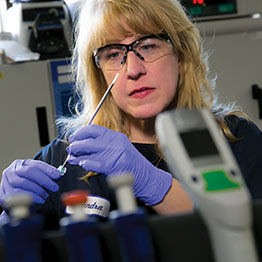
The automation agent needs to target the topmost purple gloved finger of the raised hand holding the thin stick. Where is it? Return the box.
[68,125,109,143]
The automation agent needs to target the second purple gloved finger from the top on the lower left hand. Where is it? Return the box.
[4,174,49,199]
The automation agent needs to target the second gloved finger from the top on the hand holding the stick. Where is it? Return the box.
[67,138,106,156]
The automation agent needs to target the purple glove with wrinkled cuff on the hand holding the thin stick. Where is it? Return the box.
[67,125,172,206]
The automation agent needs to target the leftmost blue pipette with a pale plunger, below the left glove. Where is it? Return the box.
[2,194,43,262]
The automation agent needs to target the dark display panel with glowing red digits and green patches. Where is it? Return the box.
[181,0,237,17]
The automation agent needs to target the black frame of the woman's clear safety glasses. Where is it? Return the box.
[93,34,172,69]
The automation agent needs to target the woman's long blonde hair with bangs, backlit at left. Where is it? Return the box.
[58,0,246,178]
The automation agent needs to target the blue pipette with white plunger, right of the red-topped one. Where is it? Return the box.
[107,174,155,262]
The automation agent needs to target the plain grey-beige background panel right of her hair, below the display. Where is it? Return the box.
[200,19,262,129]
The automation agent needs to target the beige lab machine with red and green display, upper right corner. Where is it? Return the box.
[181,0,262,36]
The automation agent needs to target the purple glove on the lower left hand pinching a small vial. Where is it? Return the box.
[0,159,61,208]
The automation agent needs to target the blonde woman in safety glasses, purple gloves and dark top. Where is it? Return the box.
[0,0,262,228]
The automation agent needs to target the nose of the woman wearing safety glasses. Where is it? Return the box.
[125,52,146,79]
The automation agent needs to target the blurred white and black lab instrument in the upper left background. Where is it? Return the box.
[4,0,72,60]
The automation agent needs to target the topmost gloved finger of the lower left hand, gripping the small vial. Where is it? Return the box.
[22,159,61,180]
